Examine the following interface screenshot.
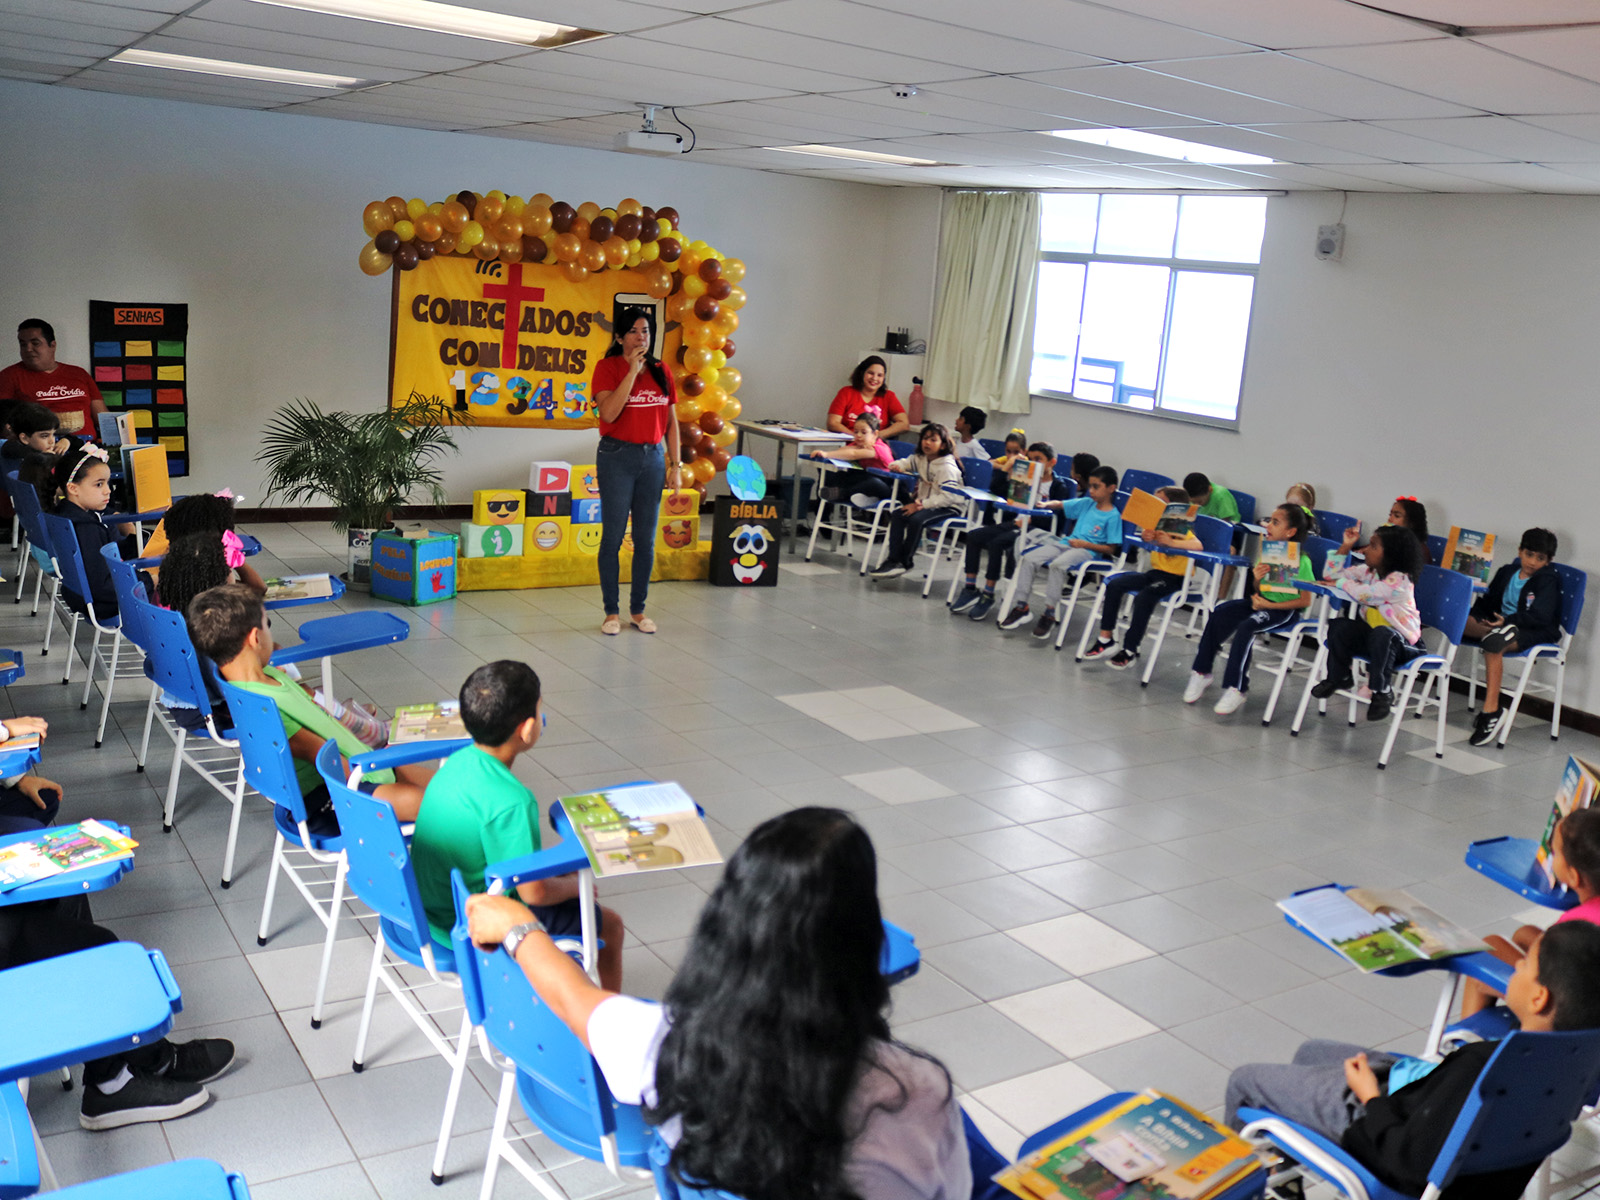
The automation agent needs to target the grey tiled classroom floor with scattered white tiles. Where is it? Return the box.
[12,525,1600,1200]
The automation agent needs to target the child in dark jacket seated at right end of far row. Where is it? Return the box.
[1467,528,1562,746]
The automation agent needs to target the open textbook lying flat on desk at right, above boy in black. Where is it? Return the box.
[1278,883,1483,973]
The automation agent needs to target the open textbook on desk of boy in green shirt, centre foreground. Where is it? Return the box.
[562,782,722,878]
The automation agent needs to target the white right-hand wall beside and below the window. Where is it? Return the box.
[934,194,1600,713]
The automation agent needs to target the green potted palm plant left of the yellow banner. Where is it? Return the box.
[256,392,462,587]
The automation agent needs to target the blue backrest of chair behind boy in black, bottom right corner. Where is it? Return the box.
[1427,1030,1600,1189]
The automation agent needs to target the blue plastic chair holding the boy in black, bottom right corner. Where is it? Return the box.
[1238,1030,1600,1200]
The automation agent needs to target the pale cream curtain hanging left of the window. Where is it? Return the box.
[928,192,1040,413]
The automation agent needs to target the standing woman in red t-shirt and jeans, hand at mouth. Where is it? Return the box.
[592,314,680,635]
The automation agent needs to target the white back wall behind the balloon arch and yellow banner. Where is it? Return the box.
[0,82,902,504]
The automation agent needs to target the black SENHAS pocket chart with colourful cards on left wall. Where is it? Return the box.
[90,301,192,475]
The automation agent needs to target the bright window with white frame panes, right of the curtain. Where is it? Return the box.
[1030,192,1267,426]
